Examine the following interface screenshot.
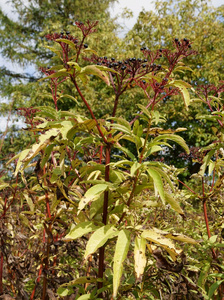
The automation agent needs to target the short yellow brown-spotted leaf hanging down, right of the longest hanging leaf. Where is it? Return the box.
[134,236,146,281]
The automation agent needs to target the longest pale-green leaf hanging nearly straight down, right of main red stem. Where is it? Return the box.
[113,229,131,298]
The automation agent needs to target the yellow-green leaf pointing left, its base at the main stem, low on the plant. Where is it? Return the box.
[63,221,100,241]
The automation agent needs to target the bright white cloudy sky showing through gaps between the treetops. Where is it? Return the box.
[0,0,224,131]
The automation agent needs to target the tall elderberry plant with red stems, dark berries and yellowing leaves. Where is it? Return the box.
[7,22,201,299]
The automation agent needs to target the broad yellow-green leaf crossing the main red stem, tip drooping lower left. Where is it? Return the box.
[84,225,119,259]
